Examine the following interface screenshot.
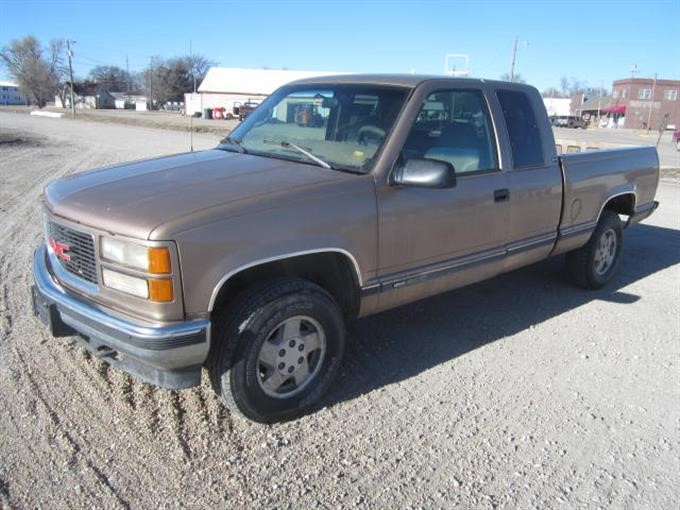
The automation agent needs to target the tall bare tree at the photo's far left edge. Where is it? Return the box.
[0,35,64,107]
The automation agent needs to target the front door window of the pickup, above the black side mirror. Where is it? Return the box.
[403,90,498,174]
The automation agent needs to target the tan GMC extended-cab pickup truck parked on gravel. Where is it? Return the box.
[32,75,659,422]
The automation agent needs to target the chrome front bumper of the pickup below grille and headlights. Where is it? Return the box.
[32,245,210,389]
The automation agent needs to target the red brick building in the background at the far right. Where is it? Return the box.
[604,78,680,130]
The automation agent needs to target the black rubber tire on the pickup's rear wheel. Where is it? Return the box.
[567,209,623,289]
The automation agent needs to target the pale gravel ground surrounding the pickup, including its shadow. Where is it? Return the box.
[0,113,680,509]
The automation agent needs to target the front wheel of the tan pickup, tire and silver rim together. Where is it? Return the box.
[210,278,345,423]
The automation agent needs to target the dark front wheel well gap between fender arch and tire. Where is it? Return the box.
[213,252,360,318]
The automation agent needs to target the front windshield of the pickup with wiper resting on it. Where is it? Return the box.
[219,85,407,173]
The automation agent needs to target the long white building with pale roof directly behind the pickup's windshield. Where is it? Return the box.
[184,67,345,115]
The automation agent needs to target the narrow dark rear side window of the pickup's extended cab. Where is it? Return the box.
[496,90,543,168]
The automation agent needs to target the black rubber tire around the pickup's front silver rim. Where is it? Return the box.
[208,278,345,423]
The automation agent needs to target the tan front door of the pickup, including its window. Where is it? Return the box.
[378,88,510,309]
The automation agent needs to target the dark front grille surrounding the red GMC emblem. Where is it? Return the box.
[47,221,98,285]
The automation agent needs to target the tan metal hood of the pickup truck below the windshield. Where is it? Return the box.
[45,149,356,239]
